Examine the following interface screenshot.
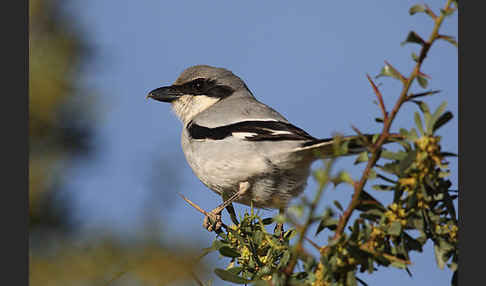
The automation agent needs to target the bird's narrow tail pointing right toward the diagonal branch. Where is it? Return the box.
[296,134,380,158]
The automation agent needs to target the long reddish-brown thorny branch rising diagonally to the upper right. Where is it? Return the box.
[333,0,452,240]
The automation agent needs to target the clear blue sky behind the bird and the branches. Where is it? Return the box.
[63,0,458,285]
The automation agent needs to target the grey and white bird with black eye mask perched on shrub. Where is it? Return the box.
[147,65,371,231]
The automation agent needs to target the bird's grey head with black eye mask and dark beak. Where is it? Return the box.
[147,65,251,124]
